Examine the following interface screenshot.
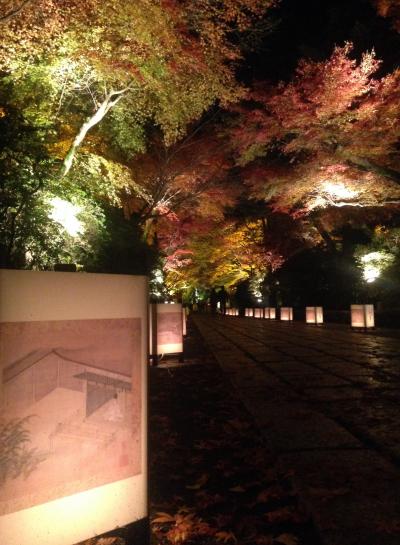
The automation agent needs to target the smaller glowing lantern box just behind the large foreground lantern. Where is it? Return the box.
[149,303,183,358]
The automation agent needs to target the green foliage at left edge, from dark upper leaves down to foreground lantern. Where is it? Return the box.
[0,78,114,269]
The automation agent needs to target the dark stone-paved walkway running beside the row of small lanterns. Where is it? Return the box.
[193,315,400,545]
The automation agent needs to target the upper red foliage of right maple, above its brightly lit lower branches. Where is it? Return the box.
[235,44,400,183]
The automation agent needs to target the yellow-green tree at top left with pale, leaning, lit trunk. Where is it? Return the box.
[0,0,274,175]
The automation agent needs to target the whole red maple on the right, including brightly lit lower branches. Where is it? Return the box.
[225,44,400,264]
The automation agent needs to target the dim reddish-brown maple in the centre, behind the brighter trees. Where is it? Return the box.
[124,123,231,240]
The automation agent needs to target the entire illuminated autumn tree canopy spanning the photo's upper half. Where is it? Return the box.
[0,0,400,306]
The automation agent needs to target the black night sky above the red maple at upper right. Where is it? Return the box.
[240,0,400,83]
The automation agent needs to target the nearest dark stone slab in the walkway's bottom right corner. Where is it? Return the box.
[281,449,400,545]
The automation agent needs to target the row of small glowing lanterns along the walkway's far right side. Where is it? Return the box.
[225,305,375,328]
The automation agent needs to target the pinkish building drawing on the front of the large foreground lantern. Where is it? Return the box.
[0,319,141,514]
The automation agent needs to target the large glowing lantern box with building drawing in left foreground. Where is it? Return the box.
[0,270,148,545]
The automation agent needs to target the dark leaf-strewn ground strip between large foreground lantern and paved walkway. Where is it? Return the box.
[149,324,319,545]
